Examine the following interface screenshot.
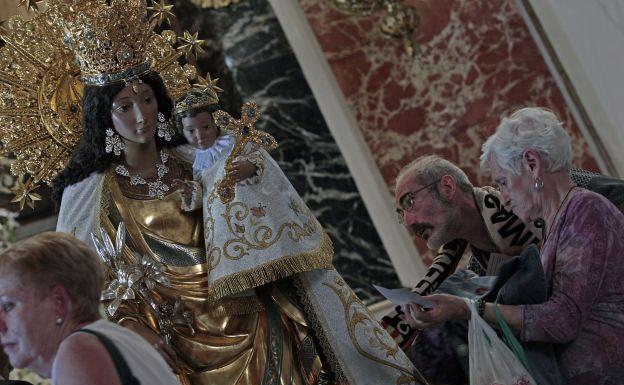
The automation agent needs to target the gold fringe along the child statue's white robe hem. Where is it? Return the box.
[208,232,334,300]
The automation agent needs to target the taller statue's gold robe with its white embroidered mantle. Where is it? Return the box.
[57,154,426,385]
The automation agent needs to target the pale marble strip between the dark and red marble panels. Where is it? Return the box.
[269,0,425,286]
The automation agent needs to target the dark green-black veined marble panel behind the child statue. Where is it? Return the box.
[176,0,399,303]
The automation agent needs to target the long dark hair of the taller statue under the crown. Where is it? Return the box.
[52,72,187,205]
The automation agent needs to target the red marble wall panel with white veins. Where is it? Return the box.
[299,0,597,262]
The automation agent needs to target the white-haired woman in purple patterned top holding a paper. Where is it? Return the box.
[406,108,624,385]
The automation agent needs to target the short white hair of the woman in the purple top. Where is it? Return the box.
[481,107,572,175]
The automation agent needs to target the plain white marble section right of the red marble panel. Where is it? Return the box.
[517,0,624,177]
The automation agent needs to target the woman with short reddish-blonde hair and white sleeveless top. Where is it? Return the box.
[0,232,179,385]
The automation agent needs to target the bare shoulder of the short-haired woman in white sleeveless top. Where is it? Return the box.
[53,333,120,385]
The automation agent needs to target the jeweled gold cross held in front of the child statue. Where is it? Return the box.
[212,102,277,204]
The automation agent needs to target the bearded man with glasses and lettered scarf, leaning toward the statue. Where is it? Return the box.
[381,155,539,383]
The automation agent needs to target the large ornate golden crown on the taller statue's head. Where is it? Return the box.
[53,0,153,86]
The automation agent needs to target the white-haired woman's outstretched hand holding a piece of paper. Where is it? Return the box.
[401,294,470,329]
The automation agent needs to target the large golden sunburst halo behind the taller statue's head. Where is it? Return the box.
[0,8,200,209]
